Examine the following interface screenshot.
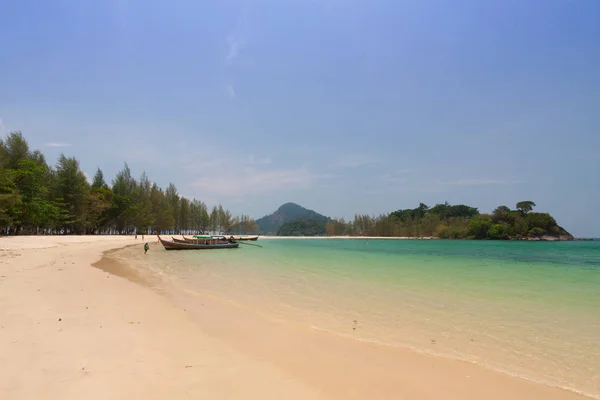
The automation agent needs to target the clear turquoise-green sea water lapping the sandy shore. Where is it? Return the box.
[116,239,600,398]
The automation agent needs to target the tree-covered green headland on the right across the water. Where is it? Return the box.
[323,201,572,240]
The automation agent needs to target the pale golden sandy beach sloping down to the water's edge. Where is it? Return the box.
[0,236,583,400]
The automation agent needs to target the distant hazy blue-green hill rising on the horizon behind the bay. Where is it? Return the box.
[256,203,329,236]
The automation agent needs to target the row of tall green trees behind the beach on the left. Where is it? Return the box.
[0,131,258,235]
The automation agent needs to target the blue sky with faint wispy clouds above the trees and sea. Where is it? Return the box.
[0,0,600,236]
